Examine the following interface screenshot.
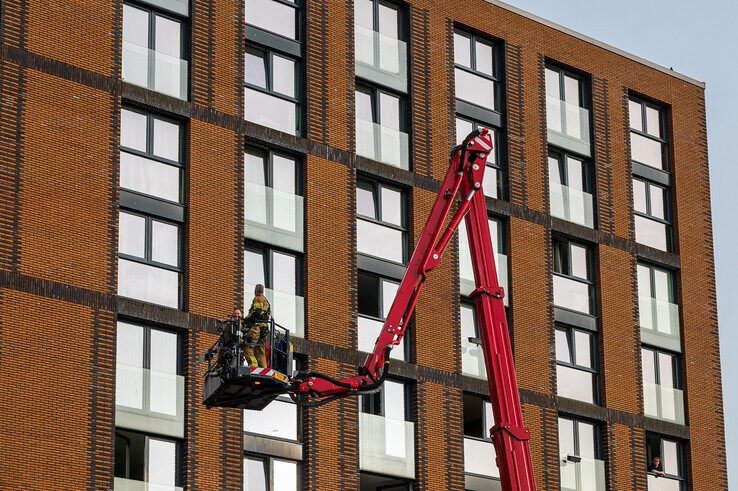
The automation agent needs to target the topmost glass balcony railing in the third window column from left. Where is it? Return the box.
[354,25,407,92]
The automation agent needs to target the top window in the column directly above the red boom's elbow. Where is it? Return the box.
[454,31,500,112]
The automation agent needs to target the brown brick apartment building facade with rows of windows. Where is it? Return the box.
[0,0,727,491]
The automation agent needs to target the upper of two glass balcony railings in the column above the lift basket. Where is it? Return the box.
[244,182,303,252]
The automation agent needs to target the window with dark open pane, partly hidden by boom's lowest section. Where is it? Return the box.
[463,394,500,479]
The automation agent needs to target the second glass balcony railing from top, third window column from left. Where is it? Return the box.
[356,118,410,170]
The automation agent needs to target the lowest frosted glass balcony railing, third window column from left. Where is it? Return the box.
[359,413,415,479]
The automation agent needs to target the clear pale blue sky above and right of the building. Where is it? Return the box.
[500,0,738,489]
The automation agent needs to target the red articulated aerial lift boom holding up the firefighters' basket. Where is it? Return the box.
[204,129,535,491]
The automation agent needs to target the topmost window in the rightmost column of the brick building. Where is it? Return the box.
[628,98,667,170]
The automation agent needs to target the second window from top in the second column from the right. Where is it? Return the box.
[548,150,594,228]
